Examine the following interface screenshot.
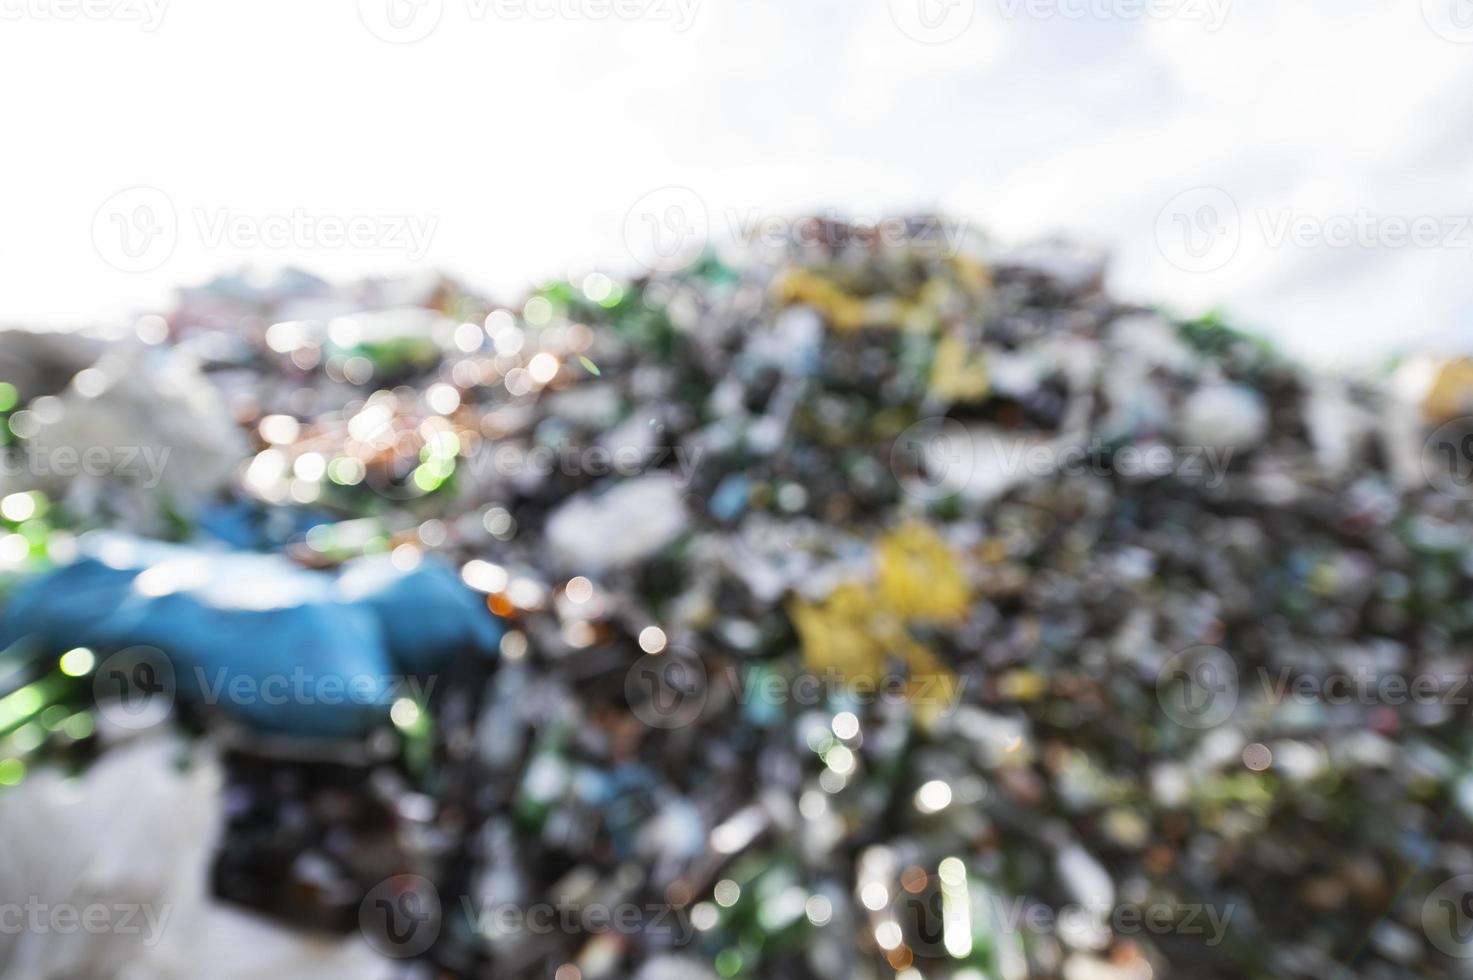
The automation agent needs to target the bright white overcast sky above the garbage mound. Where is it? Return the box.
[0,0,1473,363]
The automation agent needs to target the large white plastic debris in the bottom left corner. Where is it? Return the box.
[0,735,392,980]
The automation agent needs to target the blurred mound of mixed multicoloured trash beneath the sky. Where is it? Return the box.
[0,218,1473,980]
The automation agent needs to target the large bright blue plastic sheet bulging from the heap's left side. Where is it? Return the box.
[0,535,501,735]
